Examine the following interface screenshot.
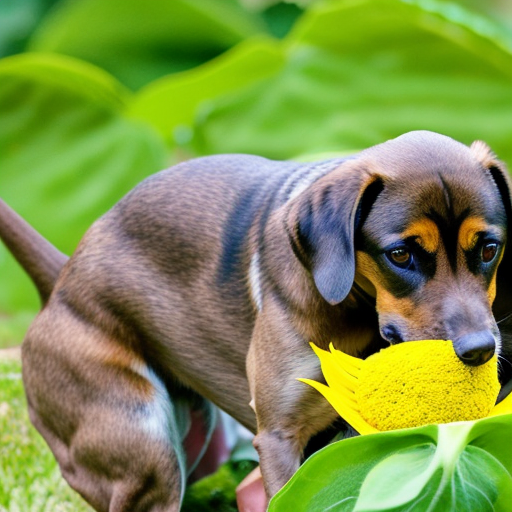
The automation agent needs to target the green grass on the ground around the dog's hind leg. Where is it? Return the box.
[0,336,255,512]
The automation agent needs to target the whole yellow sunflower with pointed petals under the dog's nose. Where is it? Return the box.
[299,340,512,434]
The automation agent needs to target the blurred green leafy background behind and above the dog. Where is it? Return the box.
[0,0,512,314]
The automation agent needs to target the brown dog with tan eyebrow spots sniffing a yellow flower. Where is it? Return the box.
[0,131,512,512]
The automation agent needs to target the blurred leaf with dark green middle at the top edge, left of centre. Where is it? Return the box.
[29,0,266,89]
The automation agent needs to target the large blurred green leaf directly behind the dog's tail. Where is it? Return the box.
[0,54,167,312]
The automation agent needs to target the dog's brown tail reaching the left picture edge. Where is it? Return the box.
[0,199,68,304]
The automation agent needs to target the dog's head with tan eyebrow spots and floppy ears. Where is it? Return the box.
[292,132,511,365]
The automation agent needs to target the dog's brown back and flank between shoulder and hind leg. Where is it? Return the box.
[47,155,299,431]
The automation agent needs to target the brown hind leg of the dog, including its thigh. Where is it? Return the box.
[22,300,190,512]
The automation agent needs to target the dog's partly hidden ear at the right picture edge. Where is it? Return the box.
[471,141,512,320]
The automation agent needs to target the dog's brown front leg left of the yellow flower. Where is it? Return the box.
[248,310,337,498]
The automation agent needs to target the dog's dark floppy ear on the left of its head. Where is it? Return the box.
[286,160,383,305]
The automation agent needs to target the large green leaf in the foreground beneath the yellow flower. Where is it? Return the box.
[269,415,512,512]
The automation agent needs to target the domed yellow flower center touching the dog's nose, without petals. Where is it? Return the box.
[356,340,500,430]
